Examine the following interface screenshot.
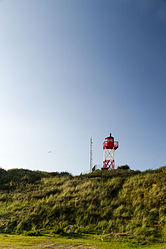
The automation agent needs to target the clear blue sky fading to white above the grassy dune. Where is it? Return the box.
[0,0,166,175]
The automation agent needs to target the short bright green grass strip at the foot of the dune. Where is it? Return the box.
[0,234,166,249]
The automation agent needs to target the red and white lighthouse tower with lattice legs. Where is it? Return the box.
[103,133,119,169]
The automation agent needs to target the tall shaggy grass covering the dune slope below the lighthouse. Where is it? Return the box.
[0,165,166,243]
